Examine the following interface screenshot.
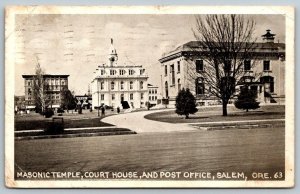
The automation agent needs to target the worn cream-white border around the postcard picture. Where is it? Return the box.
[5,6,295,188]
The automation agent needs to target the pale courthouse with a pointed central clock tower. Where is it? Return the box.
[91,39,148,108]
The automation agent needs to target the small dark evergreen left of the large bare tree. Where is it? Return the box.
[175,88,198,119]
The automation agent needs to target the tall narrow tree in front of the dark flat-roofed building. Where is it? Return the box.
[33,63,50,114]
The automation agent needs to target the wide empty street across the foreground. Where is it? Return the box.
[15,128,285,180]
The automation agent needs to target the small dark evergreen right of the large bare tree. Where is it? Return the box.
[234,86,259,112]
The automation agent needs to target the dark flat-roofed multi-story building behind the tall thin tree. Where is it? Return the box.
[22,74,69,110]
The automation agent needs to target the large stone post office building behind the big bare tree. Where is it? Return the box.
[159,30,285,105]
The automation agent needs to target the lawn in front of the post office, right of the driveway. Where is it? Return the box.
[145,105,285,123]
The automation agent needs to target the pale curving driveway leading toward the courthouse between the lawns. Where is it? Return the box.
[101,109,197,133]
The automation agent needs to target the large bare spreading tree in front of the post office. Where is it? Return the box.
[193,15,255,116]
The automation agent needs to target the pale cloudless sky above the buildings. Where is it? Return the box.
[15,14,285,95]
